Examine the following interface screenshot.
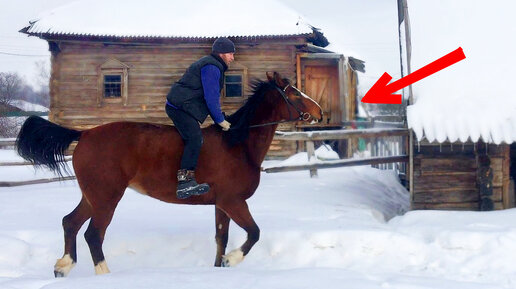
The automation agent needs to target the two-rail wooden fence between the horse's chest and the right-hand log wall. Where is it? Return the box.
[263,128,409,177]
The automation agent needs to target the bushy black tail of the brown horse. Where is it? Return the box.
[16,115,81,176]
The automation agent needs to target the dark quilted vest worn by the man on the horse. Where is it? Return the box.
[167,55,227,123]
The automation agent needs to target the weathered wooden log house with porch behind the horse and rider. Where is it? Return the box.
[20,0,363,157]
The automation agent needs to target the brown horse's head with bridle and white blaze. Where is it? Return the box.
[266,72,323,123]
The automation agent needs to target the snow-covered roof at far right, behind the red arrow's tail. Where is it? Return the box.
[407,0,516,144]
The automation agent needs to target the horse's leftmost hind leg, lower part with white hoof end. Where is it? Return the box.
[54,198,91,277]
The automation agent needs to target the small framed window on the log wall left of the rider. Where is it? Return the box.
[97,58,129,106]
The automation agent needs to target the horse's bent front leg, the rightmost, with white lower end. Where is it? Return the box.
[222,201,260,267]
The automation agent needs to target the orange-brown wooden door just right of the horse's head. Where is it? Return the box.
[305,65,344,124]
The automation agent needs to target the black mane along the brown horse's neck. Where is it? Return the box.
[225,79,289,146]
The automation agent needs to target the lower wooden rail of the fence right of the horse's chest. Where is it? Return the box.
[263,155,409,173]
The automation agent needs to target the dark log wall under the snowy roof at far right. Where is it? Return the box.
[412,142,514,210]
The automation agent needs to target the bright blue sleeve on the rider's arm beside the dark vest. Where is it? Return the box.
[201,64,224,123]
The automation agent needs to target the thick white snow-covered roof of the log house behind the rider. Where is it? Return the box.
[24,0,312,38]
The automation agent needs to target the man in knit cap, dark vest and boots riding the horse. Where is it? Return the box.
[165,37,235,199]
